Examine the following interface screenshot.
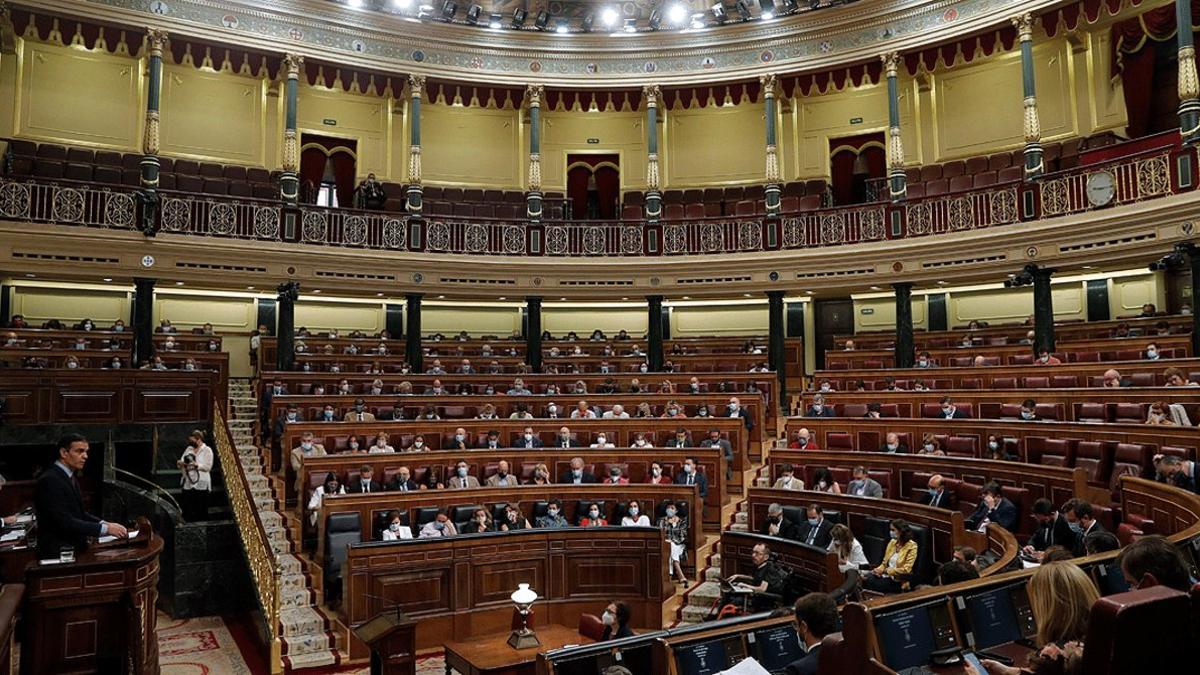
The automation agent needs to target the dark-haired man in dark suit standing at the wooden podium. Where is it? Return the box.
[34,434,128,560]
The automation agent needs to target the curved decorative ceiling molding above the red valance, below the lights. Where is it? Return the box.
[21,0,1089,89]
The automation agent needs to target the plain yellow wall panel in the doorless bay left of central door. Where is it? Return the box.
[421,104,523,190]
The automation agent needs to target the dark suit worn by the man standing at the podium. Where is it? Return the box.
[34,464,101,558]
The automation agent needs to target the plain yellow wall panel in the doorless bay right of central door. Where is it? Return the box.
[662,103,767,187]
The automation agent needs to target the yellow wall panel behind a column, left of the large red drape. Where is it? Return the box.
[930,40,1075,162]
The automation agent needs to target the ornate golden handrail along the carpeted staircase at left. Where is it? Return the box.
[212,401,283,674]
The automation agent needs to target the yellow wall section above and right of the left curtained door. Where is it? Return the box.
[296,84,386,181]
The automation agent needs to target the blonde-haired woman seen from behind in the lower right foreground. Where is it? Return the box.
[982,562,1100,675]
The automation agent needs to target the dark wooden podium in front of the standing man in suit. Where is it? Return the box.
[20,518,162,675]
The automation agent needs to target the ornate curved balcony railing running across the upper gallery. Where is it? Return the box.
[0,140,1196,257]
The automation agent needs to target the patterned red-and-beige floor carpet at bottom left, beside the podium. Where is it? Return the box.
[158,613,445,675]
